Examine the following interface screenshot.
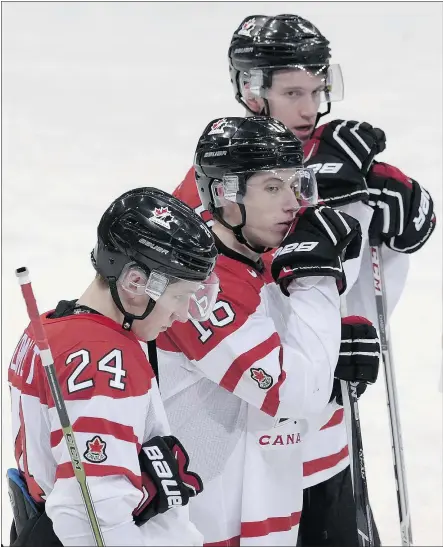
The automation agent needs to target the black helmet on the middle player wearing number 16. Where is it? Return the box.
[194,116,317,252]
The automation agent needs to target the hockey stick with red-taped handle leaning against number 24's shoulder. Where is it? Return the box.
[15,268,105,547]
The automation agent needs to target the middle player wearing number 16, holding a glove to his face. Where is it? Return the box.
[158,117,379,546]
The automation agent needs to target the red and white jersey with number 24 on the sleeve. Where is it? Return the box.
[8,312,202,546]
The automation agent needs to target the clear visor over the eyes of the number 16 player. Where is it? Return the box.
[212,167,318,207]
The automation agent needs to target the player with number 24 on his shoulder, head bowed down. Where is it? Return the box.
[8,188,218,547]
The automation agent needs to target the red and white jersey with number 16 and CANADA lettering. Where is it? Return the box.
[157,250,341,545]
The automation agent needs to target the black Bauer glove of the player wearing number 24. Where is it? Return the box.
[133,435,203,526]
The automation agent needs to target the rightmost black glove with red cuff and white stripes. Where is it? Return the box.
[367,159,436,253]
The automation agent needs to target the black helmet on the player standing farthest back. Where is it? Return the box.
[228,14,343,120]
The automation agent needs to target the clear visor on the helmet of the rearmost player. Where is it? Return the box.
[249,64,344,102]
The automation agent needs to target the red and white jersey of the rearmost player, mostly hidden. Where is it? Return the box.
[170,156,409,488]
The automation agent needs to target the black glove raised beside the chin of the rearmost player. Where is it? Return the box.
[305,120,386,207]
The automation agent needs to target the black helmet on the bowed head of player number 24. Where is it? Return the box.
[91,188,217,328]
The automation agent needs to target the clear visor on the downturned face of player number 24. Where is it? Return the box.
[118,263,219,321]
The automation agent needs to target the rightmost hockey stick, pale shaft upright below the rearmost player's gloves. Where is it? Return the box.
[370,246,413,545]
